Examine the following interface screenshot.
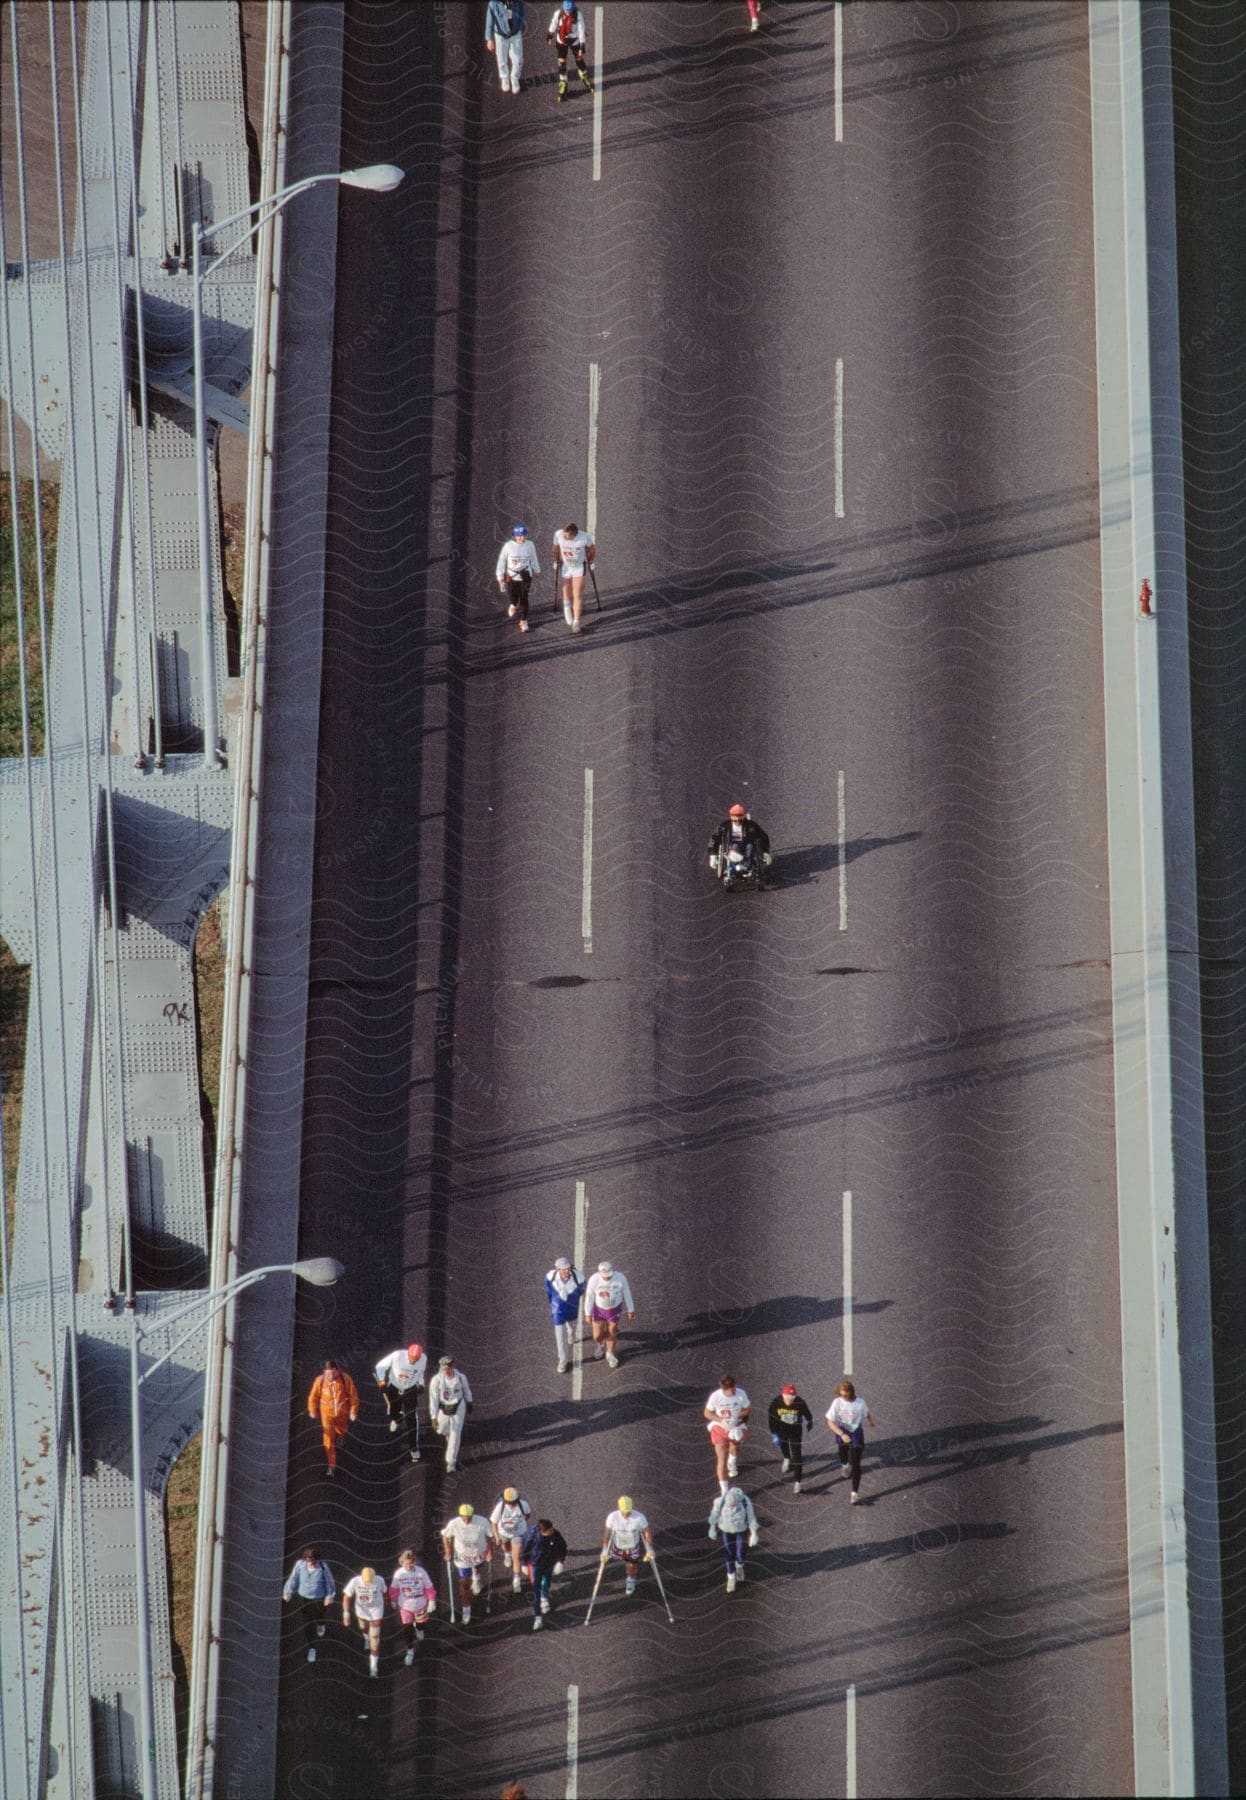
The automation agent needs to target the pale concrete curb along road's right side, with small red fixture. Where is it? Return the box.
[1089,0,1228,1795]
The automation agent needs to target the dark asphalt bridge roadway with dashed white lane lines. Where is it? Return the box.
[277,0,1133,1796]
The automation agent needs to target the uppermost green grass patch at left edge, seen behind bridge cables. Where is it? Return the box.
[0,475,61,756]
